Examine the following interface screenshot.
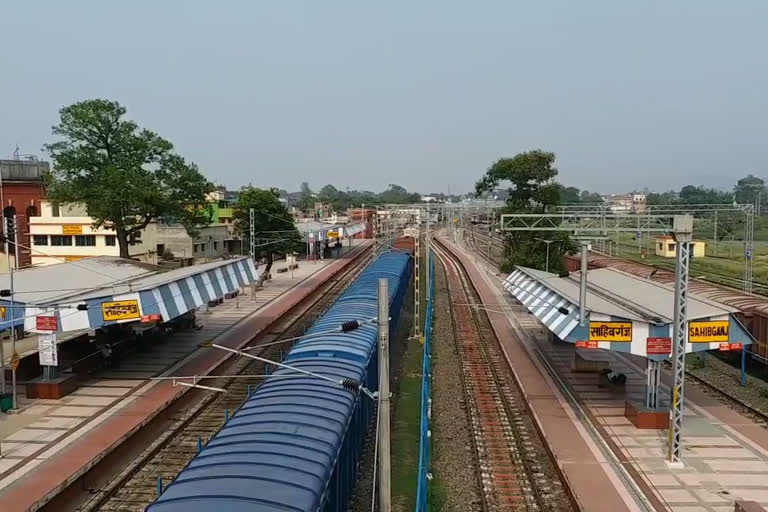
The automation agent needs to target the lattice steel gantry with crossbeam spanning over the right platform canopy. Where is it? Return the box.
[500,210,693,466]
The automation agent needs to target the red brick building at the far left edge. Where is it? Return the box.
[0,159,50,268]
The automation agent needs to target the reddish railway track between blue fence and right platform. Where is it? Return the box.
[433,241,576,512]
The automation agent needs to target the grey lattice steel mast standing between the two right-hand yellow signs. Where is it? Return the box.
[667,218,693,467]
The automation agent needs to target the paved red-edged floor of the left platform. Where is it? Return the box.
[0,240,371,512]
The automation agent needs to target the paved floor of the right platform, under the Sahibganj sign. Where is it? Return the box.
[444,233,768,512]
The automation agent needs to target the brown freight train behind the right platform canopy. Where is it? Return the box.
[564,254,768,360]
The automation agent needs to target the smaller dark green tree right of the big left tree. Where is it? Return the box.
[232,186,304,255]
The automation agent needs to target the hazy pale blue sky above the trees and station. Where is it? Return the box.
[0,0,768,192]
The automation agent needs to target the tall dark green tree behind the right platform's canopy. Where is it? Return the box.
[475,150,578,271]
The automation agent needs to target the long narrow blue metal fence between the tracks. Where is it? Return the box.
[416,247,435,512]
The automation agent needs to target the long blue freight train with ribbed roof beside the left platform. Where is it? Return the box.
[145,250,412,512]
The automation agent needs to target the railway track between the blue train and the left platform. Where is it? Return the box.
[77,252,374,512]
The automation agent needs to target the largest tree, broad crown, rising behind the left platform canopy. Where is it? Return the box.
[45,99,214,258]
